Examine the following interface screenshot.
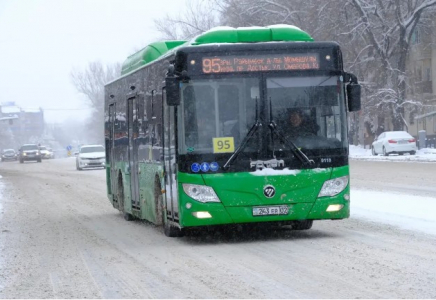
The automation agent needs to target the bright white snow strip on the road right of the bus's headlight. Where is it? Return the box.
[351,189,436,235]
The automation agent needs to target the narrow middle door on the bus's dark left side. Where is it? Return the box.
[127,96,140,210]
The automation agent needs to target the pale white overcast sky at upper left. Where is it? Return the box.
[0,0,187,123]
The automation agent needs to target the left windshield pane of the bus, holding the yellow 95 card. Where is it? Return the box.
[179,77,260,154]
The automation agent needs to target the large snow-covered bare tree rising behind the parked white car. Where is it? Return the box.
[347,0,436,130]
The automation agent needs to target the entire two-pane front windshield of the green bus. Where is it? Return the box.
[179,76,347,159]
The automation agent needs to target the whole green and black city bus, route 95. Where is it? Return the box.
[105,25,360,236]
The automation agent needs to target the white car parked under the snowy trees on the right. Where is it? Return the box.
[371,131,417,156]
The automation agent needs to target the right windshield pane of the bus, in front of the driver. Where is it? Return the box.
[266,76,347,149]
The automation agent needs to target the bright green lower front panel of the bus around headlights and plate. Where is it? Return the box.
[178,166,350,227]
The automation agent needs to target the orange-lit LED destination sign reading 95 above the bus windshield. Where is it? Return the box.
[202,54,319,74]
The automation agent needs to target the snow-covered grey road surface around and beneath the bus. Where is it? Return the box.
[0,159,436,298]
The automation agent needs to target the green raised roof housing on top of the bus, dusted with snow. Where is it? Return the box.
[121,25,313,75]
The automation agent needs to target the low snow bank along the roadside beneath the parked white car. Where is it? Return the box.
[350,145,436,162]
